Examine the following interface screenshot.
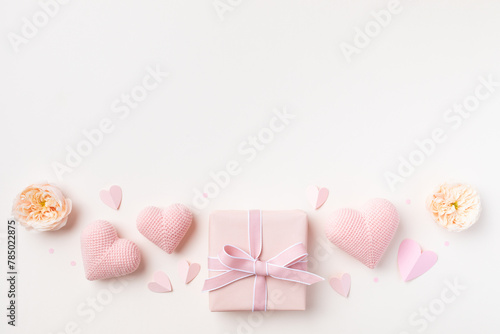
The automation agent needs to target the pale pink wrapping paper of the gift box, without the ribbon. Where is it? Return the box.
[209,210,314,312]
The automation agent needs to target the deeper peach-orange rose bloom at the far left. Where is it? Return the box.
[12,184,71,231]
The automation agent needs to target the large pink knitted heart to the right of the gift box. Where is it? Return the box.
[325,198,399,269]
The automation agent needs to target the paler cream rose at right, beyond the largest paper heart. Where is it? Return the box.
[426,183,481,232]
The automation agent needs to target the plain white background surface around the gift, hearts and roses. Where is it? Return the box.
[0,0,500,334]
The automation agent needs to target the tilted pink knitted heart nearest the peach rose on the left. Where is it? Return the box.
[80,220,141,281]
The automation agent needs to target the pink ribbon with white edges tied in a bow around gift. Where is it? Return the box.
[203,210,323,311]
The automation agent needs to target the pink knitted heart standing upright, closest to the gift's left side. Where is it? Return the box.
[137,204,193,254]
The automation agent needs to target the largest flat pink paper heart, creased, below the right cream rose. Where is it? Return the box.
[398,239,437,282]
